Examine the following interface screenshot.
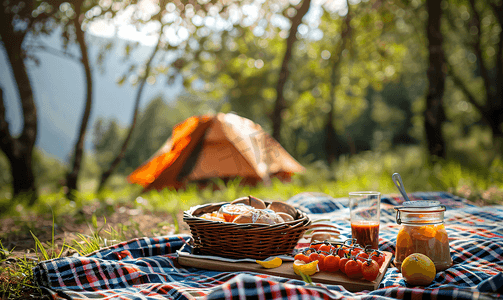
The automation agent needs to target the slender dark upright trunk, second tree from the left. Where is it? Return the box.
[66,12,93,199]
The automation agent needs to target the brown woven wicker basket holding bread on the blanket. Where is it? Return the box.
[183,202,311,259]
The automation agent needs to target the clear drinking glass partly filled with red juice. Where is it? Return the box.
[349,192,381,249]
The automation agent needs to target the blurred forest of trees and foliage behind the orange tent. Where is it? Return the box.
[0,0,503,200]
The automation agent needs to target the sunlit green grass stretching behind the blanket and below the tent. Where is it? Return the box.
[0,147,503,299]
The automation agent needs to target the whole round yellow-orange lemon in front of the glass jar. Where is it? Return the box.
[402,253,437,285]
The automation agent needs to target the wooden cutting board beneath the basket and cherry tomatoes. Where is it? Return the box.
[178,252,392,292]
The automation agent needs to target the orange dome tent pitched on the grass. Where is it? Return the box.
[128,113,304,191]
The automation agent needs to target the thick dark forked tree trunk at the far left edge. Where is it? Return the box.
[0,9,37,204]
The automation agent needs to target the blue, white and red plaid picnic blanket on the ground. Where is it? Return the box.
[33,192,503,299]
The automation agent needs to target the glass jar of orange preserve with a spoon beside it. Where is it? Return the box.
[394,200,452,272]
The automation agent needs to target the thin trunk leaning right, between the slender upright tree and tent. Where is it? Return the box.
[98,26,164,192]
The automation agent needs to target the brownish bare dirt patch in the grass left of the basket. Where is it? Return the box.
[0,206,189,259]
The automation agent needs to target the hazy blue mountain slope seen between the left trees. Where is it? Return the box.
[0,32,183,162]
